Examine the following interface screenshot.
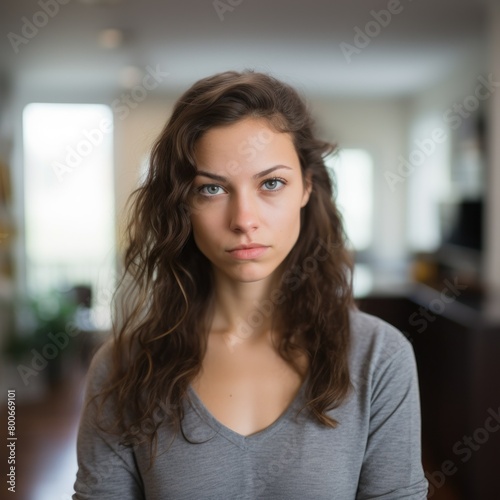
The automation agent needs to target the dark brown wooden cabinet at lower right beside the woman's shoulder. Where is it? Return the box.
[357,284,500,500]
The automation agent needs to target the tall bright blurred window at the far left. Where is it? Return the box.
[23,103,115,328]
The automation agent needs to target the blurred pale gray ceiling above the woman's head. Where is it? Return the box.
[0,0,487,96]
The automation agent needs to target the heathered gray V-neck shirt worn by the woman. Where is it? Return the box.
[73,311,427,500]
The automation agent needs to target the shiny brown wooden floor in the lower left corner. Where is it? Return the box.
[0,369,84,500]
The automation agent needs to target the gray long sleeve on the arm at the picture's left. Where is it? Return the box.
[73,345,144,500]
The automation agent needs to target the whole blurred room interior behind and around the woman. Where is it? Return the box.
[0,0,500,500]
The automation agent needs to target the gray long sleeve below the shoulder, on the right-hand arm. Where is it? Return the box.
[356,332,428,500]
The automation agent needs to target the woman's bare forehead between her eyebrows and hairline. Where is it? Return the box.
[195,118,300,175]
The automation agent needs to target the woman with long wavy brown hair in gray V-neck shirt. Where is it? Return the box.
[74,71,427,500]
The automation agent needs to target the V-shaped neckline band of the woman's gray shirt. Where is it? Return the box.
[187,375,309,450]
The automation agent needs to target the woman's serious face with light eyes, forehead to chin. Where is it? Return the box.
[191,114,311,282]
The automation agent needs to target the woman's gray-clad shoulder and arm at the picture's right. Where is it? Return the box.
[339,311,427,499]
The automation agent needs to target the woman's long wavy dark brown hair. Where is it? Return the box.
[95,71,354,460]
